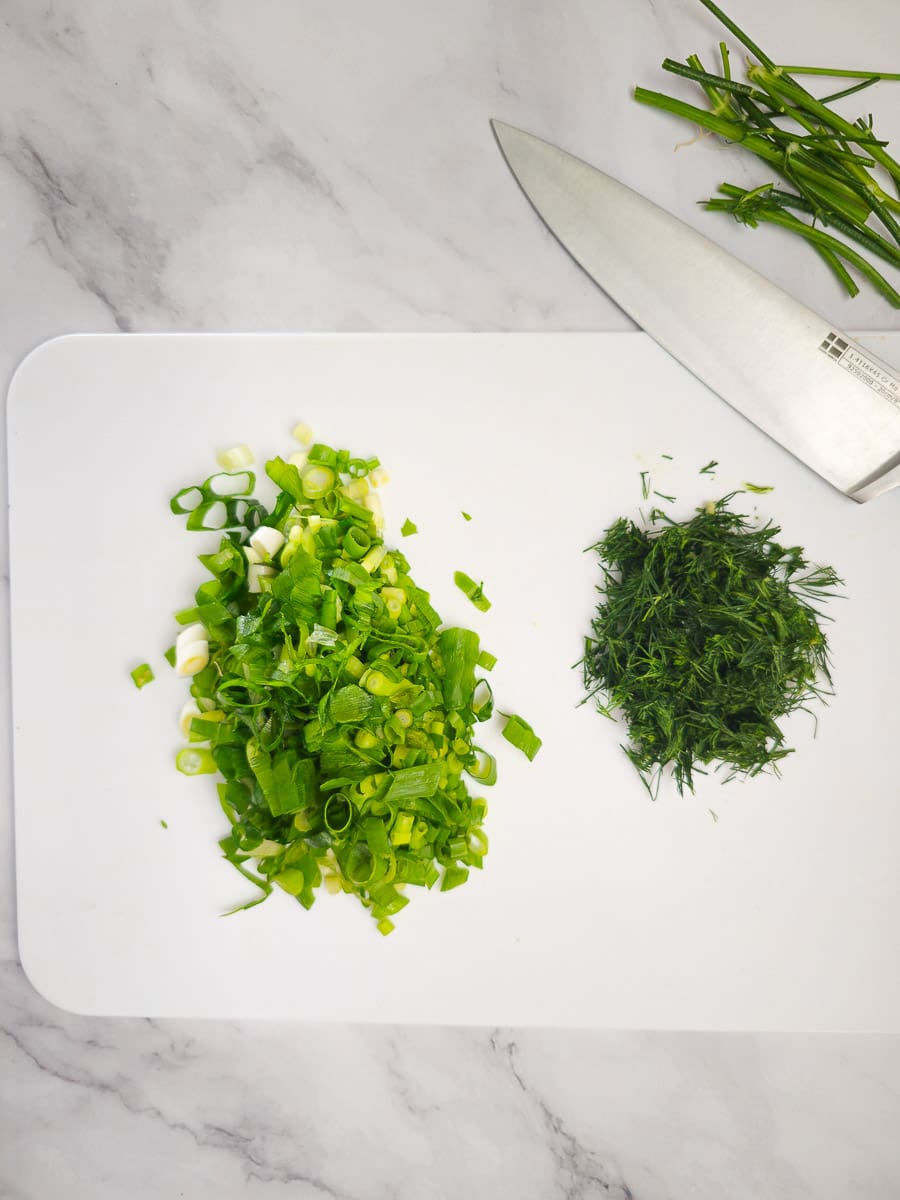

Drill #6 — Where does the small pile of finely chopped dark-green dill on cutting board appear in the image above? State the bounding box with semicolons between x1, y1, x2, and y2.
582;493;841;797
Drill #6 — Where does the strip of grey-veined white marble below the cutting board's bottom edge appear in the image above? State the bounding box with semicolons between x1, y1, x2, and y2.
0;964;900;1200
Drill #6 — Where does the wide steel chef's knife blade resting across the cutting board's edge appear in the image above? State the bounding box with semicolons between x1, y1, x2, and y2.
491;121;900;502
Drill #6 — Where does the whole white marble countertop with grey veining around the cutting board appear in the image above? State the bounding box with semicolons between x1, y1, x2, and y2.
0;0;900;1200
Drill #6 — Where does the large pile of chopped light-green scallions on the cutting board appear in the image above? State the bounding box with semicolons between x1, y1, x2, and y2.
170;434;540;934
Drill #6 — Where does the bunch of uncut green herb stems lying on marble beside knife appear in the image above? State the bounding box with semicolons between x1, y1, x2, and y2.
634;0;900;307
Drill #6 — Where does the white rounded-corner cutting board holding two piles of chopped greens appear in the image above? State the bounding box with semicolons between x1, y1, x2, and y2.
10;334;900;1031
